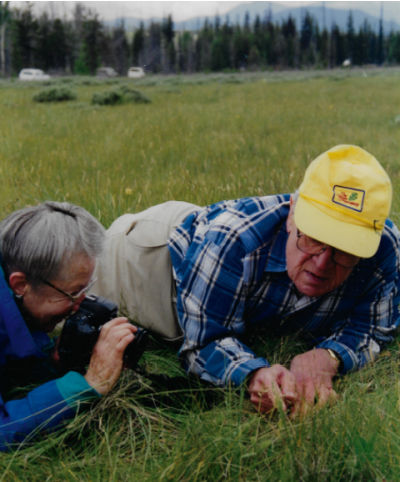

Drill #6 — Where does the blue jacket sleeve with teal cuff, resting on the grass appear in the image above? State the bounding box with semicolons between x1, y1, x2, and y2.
0;372;100;451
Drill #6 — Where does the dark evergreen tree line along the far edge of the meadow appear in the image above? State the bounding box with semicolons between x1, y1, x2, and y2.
0;1;400;76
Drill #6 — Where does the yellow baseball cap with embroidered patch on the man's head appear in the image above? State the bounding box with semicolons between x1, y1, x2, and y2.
294;145;392;258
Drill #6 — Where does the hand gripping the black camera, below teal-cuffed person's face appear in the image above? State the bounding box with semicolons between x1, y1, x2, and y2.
85;318;137;395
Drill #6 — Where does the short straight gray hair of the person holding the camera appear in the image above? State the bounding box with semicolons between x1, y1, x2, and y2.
0;201;105;284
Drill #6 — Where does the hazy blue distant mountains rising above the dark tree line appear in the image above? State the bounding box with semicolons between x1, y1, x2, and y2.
105;2;400;33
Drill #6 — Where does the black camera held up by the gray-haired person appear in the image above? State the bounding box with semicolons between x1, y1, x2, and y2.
58;295;148;373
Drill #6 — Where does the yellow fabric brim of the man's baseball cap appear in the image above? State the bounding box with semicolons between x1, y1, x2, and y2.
294;197;382;258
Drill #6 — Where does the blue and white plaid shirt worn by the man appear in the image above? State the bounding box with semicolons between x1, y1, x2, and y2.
169;194;400;386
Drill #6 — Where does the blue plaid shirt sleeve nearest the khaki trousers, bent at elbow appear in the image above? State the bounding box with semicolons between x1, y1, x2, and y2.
177;235;269;386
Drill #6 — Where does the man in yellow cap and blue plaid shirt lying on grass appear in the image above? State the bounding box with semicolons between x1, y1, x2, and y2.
95;145;400;413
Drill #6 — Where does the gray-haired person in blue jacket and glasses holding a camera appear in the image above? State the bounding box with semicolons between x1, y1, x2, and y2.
0;202;136;450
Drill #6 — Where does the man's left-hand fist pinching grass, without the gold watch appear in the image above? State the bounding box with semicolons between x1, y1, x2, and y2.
248;365;297;413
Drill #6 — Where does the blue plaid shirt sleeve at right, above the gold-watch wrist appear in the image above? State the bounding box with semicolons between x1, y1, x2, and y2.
317;227;400;373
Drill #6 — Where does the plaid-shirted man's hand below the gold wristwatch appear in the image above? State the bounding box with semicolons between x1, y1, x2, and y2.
290;348;339;415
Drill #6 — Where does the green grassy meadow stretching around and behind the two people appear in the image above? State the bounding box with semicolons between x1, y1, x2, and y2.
0;69;400;481
